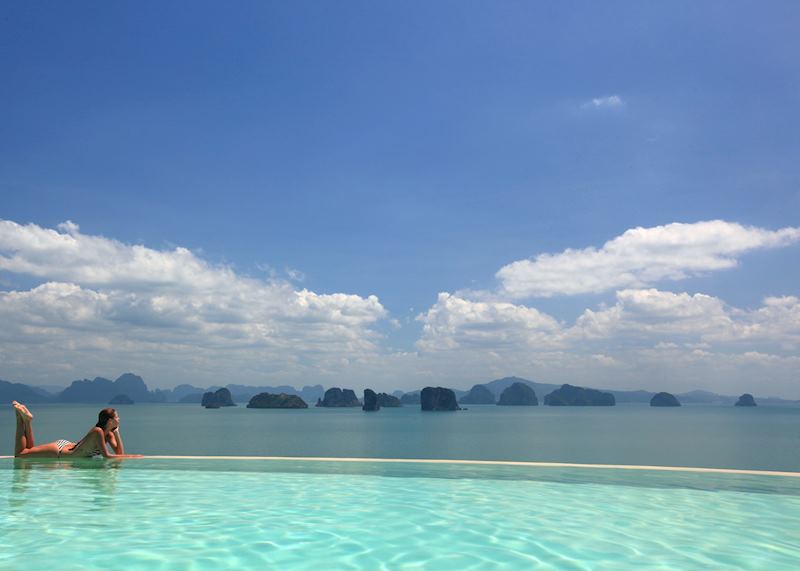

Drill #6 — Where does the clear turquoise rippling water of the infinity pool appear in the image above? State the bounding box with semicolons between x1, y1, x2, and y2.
0;459;800;571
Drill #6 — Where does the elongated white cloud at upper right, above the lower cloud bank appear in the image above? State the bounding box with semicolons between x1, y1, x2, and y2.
496;220;800;299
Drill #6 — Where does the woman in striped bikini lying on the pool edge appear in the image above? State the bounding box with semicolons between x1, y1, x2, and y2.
12;401;142;458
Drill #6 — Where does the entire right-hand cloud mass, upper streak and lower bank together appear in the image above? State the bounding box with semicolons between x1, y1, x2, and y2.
410;220;800;397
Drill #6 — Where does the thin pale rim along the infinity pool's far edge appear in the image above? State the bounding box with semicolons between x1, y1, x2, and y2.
0;455;800;478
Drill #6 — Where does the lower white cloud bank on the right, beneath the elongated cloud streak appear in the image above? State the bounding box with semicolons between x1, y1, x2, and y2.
418;289;800;398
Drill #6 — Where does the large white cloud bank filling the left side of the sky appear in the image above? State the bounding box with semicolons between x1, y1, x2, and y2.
0;221;387;386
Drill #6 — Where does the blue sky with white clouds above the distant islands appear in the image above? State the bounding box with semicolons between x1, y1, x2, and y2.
0;2;800;399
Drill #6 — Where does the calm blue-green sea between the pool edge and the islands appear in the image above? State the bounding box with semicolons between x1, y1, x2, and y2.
0;404;800;471
